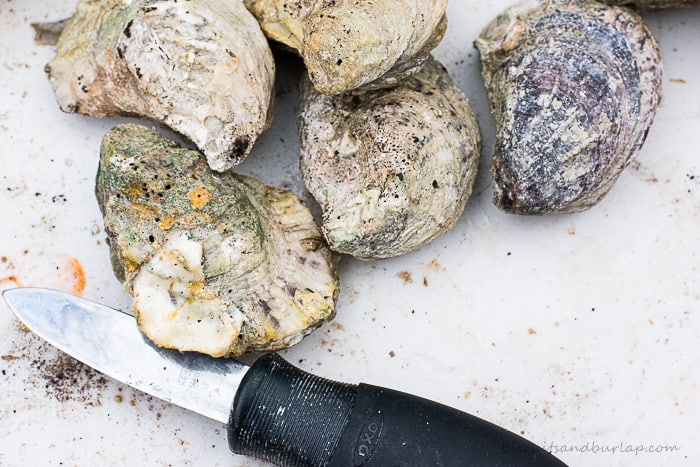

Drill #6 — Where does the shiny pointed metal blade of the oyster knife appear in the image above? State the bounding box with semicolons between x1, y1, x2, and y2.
2;288;248;423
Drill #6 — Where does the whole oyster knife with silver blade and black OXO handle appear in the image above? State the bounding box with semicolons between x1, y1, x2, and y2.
3;288;566;467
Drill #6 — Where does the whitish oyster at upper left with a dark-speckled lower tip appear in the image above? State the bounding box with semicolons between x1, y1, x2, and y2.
46;0;274;171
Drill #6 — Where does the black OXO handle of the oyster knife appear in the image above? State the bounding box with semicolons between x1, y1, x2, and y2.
228;354;566;467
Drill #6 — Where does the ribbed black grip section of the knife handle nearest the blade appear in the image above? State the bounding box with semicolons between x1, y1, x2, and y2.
228;354;357;467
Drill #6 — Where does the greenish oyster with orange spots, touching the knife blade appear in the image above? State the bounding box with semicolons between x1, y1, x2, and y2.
96;124;338;356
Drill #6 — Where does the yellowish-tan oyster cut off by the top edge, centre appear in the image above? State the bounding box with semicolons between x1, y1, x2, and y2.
245;0;447;95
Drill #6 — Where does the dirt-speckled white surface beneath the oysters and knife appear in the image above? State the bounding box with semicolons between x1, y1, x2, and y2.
0;0;700;466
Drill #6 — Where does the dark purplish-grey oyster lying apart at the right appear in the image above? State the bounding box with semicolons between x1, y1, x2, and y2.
475;0;662;214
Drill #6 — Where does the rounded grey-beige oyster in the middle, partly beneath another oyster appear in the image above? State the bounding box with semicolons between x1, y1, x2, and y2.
300;58;481;259
